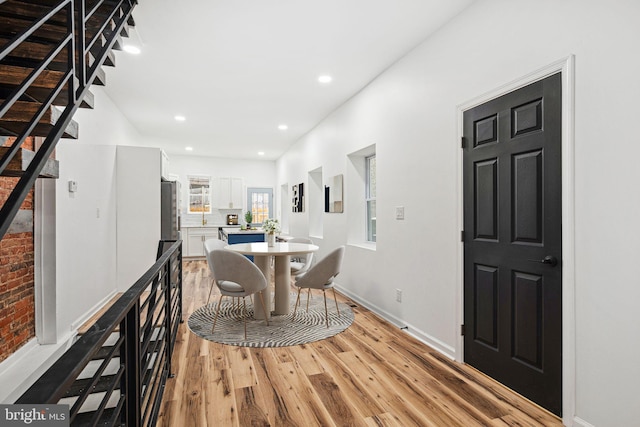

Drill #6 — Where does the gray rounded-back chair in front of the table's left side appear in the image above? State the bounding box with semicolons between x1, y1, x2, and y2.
211;249;269;339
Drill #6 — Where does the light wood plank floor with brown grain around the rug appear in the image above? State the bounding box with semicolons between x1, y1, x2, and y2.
158;261;562;427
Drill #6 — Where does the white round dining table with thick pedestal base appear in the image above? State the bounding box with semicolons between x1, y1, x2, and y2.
225;242;319;319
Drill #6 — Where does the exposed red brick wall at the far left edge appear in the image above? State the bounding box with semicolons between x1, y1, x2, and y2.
0;138;35;361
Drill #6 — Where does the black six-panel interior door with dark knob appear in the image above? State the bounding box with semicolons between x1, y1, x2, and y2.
463;74;562;415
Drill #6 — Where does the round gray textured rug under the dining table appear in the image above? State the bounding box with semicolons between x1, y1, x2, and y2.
188;291;354;347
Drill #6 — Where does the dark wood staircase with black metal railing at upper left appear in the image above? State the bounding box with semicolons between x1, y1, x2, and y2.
0;0;137;239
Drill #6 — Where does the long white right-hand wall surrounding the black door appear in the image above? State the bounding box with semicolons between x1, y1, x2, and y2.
277;0;640;426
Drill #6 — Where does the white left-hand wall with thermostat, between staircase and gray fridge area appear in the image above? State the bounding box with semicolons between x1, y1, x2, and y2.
56;86;140;336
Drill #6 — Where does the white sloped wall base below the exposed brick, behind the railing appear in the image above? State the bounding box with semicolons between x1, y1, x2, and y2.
0;332;75;403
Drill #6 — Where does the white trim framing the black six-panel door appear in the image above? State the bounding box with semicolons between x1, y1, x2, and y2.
454;55;576;425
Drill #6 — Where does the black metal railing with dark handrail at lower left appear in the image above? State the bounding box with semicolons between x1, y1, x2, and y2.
15;240;182;426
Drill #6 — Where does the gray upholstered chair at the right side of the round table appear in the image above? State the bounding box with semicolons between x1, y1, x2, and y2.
292;246;344;328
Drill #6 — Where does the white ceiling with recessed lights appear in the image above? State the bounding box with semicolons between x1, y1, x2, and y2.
105;0;473;159
